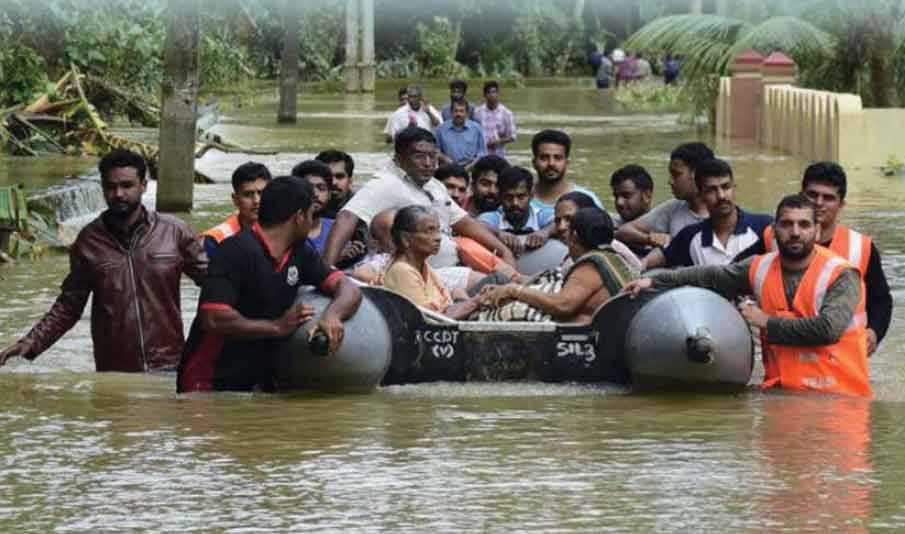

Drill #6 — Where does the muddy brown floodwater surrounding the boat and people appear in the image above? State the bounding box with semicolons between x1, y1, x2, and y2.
0;83;905;533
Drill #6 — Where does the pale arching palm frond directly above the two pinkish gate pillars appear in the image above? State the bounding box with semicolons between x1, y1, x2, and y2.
728;17;836;60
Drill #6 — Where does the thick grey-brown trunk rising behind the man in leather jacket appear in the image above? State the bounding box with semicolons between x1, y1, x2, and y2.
157;0;200;212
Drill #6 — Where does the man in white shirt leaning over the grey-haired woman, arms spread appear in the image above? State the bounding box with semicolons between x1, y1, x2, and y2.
323;127;515;268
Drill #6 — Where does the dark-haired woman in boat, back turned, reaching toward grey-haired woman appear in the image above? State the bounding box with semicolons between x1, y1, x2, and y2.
484;207;636;323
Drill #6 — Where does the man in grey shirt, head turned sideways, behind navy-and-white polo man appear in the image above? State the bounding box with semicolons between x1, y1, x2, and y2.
616;143;714;251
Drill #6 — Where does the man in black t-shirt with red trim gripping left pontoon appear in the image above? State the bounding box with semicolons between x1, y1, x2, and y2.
177;176;361;393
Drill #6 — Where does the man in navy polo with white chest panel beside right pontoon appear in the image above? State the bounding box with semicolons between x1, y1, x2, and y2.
643;159;773;269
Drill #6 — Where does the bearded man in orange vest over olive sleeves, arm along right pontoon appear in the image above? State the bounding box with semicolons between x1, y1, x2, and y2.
624;194;871;397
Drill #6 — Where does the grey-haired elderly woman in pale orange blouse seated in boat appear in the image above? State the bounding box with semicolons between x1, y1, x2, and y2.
383;206;483;319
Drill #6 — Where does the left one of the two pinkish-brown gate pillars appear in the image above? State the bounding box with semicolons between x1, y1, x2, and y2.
727;50;764;141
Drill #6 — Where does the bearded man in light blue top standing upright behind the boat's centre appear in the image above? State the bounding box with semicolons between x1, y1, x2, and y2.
531;130;603;221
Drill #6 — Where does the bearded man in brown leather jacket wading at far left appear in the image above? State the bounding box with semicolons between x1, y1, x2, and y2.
0;150;207;372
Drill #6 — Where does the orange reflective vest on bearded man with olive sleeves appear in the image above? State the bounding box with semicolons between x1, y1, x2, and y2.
748;245;871;396
